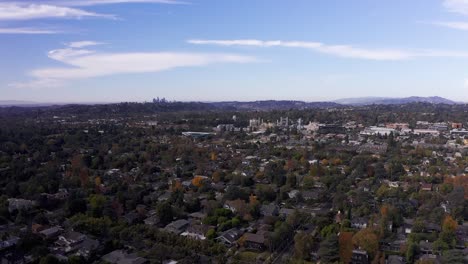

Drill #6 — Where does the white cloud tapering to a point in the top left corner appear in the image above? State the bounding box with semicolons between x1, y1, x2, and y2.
0;2;115;20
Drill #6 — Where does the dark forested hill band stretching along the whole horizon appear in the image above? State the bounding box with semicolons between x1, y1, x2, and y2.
0;101;467;118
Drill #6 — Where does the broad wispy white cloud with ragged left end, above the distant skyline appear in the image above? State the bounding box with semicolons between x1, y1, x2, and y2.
11;42;257;87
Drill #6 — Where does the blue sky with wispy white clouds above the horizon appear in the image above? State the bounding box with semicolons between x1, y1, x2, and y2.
0;0;468;102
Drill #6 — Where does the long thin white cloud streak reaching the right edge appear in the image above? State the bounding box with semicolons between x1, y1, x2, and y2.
187;39;468;61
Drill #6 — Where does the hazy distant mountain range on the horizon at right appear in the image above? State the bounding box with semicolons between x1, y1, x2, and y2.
334;96;458;105
